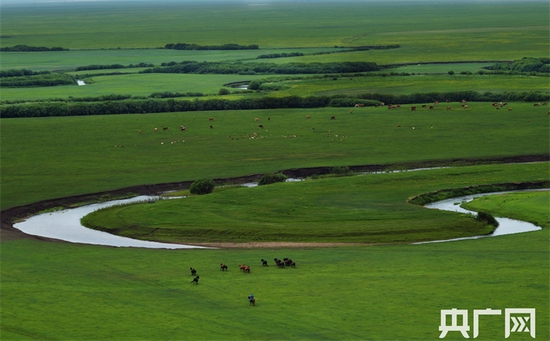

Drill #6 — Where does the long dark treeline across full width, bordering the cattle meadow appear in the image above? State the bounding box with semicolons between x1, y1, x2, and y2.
0;91;550;118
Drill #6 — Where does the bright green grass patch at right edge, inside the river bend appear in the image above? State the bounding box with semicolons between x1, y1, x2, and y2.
462;191;550;227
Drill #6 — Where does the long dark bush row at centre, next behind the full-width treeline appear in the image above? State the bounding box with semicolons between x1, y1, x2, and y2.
141;61;380;75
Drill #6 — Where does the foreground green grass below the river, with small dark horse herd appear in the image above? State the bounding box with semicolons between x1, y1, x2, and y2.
0;224;550;340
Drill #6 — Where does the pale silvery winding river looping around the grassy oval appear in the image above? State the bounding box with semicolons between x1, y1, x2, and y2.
14;190;541;249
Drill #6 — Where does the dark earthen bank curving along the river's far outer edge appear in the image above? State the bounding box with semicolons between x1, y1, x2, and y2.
0;155;550;247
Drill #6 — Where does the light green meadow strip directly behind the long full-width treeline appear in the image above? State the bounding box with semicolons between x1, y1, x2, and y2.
2;72;548;101
